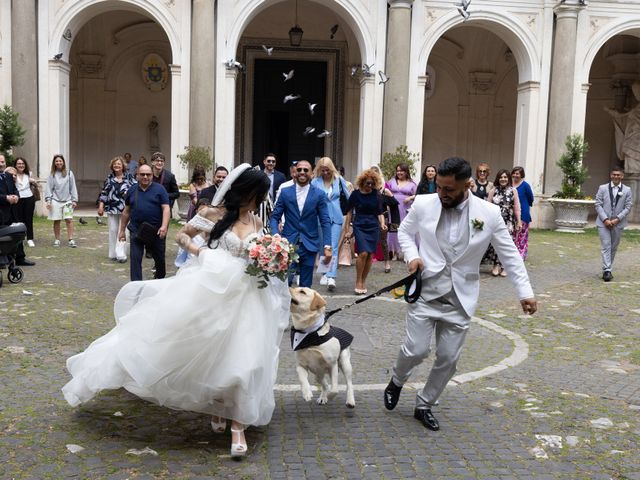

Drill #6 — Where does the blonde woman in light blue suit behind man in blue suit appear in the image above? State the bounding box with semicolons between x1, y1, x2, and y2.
311;157;349;292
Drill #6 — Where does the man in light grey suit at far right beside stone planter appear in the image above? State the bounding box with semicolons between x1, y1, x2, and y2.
596;167;631;282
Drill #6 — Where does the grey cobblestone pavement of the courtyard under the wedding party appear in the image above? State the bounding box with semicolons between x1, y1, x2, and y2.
0;220;640;479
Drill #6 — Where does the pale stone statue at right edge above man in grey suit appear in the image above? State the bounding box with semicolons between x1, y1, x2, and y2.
605;81;640;173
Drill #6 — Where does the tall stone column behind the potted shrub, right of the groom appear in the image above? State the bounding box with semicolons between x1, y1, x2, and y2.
544;0;583;195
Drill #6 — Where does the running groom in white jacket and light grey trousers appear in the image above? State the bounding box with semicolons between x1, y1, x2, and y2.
384;157;537;430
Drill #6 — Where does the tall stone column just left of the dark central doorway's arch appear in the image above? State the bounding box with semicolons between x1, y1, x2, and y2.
189;0;216;153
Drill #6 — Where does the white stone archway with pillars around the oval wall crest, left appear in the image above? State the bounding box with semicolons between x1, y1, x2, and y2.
38;0;190;188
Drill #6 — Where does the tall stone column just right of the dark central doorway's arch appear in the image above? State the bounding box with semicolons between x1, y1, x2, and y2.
376;0;413;155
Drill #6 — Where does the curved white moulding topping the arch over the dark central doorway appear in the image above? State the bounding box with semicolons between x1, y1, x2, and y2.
222;0;378;64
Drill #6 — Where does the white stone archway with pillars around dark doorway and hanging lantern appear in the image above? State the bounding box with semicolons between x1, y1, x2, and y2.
215;0;386;175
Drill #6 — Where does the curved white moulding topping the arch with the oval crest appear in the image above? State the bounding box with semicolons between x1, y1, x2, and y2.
48;0;180;64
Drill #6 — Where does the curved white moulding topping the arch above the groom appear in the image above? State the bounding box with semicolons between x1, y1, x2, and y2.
418;8;541;83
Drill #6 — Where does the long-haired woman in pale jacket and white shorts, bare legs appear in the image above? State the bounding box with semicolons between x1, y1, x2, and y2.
44;153;78;248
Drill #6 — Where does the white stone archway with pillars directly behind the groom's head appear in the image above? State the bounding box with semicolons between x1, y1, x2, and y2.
407;5;546;191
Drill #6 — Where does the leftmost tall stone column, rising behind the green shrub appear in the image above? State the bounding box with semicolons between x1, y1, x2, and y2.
11;0;38;172
